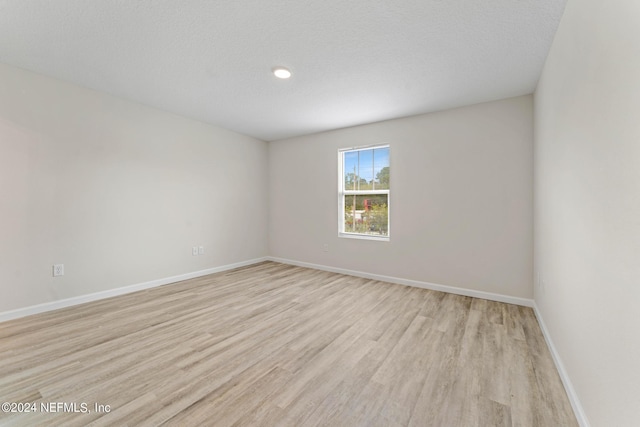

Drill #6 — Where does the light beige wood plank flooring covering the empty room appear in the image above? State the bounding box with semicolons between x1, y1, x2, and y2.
0;262;577;427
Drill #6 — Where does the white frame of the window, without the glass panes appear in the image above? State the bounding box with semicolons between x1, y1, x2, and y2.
338;144;391;242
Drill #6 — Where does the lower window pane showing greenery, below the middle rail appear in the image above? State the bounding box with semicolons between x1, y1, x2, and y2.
344;194;389;236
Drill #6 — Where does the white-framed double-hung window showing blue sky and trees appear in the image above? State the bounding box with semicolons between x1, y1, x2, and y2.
338;145;390;240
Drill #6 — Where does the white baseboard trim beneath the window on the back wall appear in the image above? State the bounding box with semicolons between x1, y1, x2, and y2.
267;256;533;307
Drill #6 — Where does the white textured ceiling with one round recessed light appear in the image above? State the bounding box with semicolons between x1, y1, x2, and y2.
0;0;566;141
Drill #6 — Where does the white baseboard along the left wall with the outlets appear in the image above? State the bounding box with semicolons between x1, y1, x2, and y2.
0;257;267;322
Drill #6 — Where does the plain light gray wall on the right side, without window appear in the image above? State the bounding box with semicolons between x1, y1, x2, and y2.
535;0;640;426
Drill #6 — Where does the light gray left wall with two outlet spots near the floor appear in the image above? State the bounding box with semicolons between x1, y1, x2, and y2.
0;61;268;312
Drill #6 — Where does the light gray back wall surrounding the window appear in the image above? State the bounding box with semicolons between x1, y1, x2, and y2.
269;96;533;298
